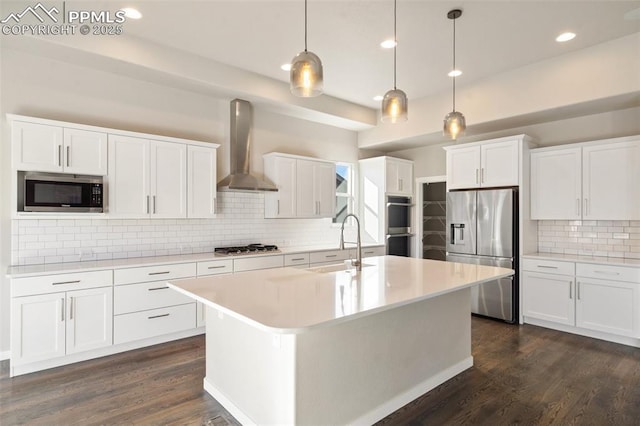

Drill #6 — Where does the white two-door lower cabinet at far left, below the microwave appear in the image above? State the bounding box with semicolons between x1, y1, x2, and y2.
11;273;113;366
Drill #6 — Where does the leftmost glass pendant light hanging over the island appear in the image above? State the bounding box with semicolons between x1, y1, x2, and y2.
289;0;322;98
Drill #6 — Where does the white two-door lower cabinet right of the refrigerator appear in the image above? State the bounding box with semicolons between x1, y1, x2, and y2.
522;259;640;345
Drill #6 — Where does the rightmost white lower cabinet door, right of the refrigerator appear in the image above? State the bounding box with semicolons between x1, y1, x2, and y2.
576;278;640;337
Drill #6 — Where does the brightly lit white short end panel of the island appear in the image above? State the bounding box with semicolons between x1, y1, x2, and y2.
204;307;296;425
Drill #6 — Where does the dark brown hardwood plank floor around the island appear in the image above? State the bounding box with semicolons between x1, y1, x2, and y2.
0;318;640;426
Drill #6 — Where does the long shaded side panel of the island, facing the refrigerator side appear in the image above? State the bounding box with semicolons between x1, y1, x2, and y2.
296;288;473;425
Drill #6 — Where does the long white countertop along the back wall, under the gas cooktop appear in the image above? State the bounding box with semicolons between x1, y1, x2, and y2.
7;244;381;278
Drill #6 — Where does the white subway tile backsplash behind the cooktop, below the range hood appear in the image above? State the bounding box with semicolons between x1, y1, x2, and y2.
11;192;350;265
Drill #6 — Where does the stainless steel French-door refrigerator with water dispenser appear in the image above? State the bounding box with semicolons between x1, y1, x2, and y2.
446;188;518;323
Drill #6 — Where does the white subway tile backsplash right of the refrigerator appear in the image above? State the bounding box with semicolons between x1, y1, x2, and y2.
538;220;640;259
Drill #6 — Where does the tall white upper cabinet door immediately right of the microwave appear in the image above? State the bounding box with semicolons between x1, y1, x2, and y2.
107;135;150;217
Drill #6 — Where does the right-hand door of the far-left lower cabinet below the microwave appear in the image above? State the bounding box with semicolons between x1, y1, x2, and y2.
66;287;113;354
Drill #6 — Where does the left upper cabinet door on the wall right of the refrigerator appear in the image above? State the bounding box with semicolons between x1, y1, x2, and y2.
531;148;582;220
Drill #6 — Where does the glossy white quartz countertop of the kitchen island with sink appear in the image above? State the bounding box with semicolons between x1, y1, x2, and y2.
169;256;514;333
